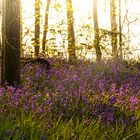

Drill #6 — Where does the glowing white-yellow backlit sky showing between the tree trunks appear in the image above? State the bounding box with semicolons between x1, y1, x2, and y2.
0;0;140;56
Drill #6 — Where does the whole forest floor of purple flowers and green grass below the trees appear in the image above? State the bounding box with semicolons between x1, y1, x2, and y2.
0;58;140;140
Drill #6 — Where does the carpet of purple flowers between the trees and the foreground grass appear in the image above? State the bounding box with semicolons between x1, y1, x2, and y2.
0;59;140;125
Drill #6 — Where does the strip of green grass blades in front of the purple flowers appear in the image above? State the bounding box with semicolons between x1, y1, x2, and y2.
0;112;140;140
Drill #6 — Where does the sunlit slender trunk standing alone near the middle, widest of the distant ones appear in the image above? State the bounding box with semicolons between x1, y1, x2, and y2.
66;0;76;61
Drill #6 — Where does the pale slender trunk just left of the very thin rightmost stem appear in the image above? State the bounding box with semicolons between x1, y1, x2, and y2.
110;0;118;58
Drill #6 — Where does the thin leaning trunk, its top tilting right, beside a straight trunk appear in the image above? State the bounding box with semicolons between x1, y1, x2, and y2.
42;0;51;53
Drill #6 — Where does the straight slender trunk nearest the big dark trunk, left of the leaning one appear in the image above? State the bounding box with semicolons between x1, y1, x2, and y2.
35;0;40;57
